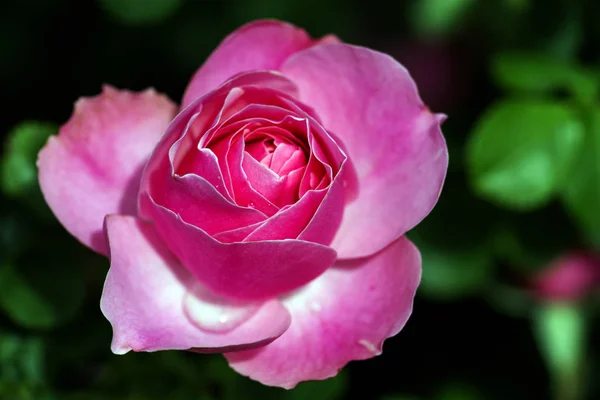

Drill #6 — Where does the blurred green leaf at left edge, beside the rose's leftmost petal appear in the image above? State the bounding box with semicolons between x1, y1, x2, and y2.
0;121;58;197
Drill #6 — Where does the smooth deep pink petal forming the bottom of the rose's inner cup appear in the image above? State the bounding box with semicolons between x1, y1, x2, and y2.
148;199;336;300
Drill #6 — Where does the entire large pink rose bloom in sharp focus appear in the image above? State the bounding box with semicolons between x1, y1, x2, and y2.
38;21;448;388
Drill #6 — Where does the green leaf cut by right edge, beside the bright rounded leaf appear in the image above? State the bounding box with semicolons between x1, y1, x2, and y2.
562;109;600;246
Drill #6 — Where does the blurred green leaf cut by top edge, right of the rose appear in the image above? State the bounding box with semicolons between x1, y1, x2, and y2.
410;0;476;37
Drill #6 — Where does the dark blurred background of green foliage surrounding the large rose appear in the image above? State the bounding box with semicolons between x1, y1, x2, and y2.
0;0;600;400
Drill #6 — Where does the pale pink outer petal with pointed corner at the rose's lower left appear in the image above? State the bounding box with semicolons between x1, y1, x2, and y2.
100;215;290;354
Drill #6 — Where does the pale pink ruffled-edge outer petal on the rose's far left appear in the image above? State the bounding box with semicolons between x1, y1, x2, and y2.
38;86;176;254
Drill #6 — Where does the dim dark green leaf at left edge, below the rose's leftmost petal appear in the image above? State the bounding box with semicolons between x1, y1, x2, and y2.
0;255;85;329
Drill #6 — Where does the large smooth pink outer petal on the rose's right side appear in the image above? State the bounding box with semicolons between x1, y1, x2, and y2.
281;43;448;258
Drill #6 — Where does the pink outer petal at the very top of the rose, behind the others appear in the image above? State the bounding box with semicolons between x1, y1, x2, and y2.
183;20;312;107
